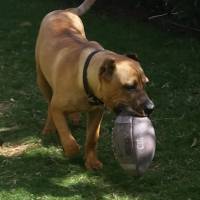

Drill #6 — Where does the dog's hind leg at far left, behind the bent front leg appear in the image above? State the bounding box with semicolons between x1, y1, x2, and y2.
37;66;56;134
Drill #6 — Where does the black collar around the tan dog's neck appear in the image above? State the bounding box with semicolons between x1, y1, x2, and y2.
83;50;104;105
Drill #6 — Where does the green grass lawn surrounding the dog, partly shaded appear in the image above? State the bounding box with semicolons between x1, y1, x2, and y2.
0;0;200;200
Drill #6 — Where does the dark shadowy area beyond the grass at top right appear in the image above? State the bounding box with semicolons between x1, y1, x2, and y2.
67;0;200;34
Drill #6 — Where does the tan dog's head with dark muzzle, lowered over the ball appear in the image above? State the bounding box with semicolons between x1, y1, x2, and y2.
99;54;154;116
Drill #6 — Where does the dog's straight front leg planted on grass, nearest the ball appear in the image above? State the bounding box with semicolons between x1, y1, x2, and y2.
85;108;103;170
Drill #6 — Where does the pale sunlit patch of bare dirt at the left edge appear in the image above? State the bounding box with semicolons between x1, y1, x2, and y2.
0;144;38;157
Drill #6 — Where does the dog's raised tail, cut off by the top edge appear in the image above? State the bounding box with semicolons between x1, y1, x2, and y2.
68;0;96;16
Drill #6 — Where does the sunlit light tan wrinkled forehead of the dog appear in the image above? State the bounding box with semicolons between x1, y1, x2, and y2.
116;60;147;86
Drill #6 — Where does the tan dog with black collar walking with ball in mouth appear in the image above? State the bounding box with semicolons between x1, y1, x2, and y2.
36;0;153;169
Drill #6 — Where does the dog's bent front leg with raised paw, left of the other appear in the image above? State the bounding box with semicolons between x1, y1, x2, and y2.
51;101;80;157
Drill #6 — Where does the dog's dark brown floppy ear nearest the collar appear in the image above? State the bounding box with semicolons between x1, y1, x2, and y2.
99;59;116;81
